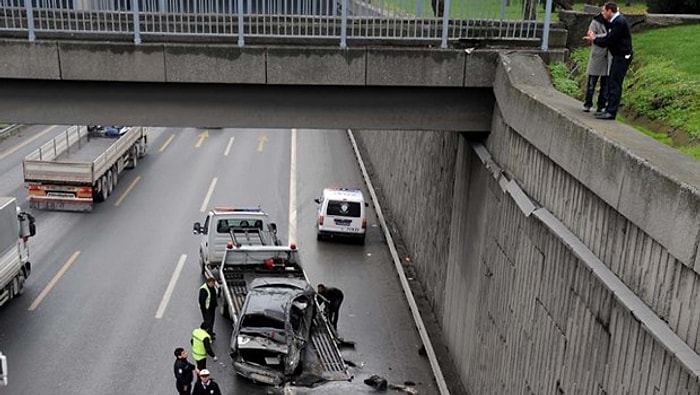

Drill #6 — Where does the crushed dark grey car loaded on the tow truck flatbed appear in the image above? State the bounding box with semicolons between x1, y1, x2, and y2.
231;277;316;385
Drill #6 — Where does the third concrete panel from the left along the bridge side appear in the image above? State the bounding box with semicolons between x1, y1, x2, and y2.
165;44;267;84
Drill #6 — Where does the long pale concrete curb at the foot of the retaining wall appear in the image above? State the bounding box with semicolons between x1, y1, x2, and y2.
347;129;450;395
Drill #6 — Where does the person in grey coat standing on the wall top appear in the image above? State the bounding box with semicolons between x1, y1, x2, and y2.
583;13;610;113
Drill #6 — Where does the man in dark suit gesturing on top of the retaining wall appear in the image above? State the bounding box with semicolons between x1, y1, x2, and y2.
585;3;632;120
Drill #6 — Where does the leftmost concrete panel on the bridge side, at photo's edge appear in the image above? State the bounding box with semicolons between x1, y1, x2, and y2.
0;40;61;80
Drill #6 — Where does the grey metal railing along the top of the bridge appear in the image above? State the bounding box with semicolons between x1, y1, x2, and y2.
0;0;552;50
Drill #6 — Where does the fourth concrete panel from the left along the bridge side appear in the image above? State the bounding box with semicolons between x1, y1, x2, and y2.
267;46;366;85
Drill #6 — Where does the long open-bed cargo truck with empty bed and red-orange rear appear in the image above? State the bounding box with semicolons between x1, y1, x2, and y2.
22;125;148;211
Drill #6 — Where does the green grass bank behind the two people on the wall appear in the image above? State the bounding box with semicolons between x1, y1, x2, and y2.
550;25;700;159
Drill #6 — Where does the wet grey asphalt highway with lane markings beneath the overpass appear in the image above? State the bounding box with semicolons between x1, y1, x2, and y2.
0;126;437;395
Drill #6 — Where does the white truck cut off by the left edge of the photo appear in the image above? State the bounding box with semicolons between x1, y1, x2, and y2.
0;197;36;306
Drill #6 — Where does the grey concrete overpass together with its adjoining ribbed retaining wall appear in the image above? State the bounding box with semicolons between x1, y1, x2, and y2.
0;2;700;394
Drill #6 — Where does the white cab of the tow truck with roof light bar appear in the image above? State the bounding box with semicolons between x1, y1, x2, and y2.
192;206;280;274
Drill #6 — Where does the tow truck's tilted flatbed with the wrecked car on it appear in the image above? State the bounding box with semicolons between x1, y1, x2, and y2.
206;240;351;385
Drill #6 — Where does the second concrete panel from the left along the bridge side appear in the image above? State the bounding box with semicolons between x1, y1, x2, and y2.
58;42;166;82
